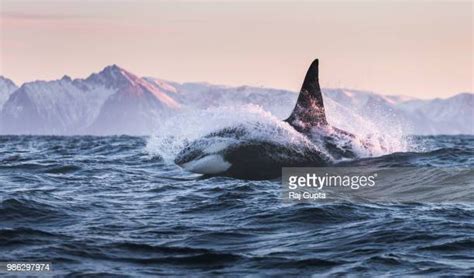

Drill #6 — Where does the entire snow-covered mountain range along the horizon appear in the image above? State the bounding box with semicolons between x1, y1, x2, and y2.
0;65;474;135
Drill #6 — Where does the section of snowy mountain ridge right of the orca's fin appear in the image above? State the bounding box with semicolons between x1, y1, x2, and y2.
323;89;474;135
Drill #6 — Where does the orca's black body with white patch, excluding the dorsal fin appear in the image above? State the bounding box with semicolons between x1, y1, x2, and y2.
175;125;329;179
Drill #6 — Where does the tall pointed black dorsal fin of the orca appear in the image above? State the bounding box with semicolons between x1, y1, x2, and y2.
285;59;328;132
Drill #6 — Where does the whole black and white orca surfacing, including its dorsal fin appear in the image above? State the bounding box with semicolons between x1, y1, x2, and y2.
175;59;370;179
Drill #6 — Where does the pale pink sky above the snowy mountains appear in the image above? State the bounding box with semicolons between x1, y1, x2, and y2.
0;0;474;98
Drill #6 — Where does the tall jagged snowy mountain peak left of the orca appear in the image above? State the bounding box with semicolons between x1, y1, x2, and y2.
0;65;179;134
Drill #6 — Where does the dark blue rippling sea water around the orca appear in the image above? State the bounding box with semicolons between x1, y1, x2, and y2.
0;136;474;277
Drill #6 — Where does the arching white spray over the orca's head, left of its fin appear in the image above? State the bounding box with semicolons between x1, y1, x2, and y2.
147;104;312;161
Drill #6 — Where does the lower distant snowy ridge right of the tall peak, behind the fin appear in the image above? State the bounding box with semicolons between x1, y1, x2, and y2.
140;80;474;135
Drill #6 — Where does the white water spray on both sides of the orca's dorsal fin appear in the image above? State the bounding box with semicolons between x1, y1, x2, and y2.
147;100;410;162
